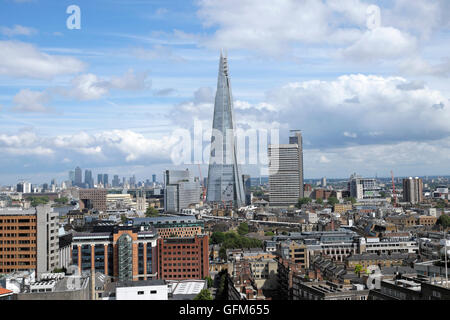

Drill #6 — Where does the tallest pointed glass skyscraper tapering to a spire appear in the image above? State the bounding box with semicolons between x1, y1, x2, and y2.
206;53;245;208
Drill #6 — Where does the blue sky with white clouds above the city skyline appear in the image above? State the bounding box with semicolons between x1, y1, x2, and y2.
0;0;450;185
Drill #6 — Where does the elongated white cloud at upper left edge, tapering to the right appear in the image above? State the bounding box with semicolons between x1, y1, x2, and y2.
0;41;85;79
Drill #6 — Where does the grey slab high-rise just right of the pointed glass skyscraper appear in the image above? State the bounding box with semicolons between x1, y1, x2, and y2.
268;130;304;207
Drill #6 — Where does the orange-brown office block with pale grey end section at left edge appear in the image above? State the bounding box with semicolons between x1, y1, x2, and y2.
0;205;59;276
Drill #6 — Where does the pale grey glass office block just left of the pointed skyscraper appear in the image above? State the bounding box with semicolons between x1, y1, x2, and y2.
164;169;201;212
